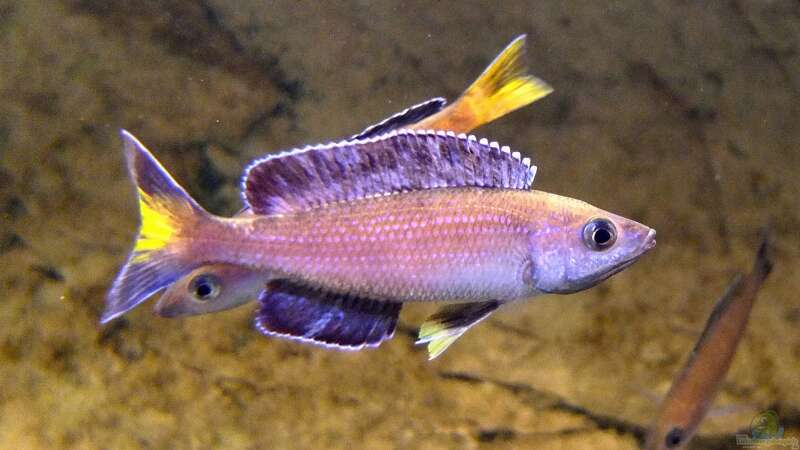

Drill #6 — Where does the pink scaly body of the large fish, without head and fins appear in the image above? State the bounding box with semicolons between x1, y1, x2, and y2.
206;189;535;301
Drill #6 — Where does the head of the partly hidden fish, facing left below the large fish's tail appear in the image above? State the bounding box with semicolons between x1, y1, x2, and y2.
153;264;271;317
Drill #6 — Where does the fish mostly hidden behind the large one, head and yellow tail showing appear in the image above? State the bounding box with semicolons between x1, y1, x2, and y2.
153;34;553;317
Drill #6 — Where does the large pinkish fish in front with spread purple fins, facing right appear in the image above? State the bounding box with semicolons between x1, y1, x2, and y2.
101;129;656;359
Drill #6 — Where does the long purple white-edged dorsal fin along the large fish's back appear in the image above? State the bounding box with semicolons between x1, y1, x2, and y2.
242;130;536;215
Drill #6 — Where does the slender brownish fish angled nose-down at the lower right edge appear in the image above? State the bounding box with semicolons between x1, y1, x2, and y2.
645;232;773;450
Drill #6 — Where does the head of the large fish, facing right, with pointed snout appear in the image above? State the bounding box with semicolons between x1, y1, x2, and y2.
527;194;656;294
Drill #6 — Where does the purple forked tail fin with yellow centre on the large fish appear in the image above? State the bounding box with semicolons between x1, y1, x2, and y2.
100;130;208;323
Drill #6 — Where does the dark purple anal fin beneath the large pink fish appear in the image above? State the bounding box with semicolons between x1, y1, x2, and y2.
255;280;402;350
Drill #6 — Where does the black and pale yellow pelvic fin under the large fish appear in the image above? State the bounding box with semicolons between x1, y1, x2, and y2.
416;300;500;359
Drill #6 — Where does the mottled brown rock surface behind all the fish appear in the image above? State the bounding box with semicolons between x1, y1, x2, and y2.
0;0;800;449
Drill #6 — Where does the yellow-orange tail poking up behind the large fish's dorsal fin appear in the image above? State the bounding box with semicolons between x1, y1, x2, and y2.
412;35;553;133
